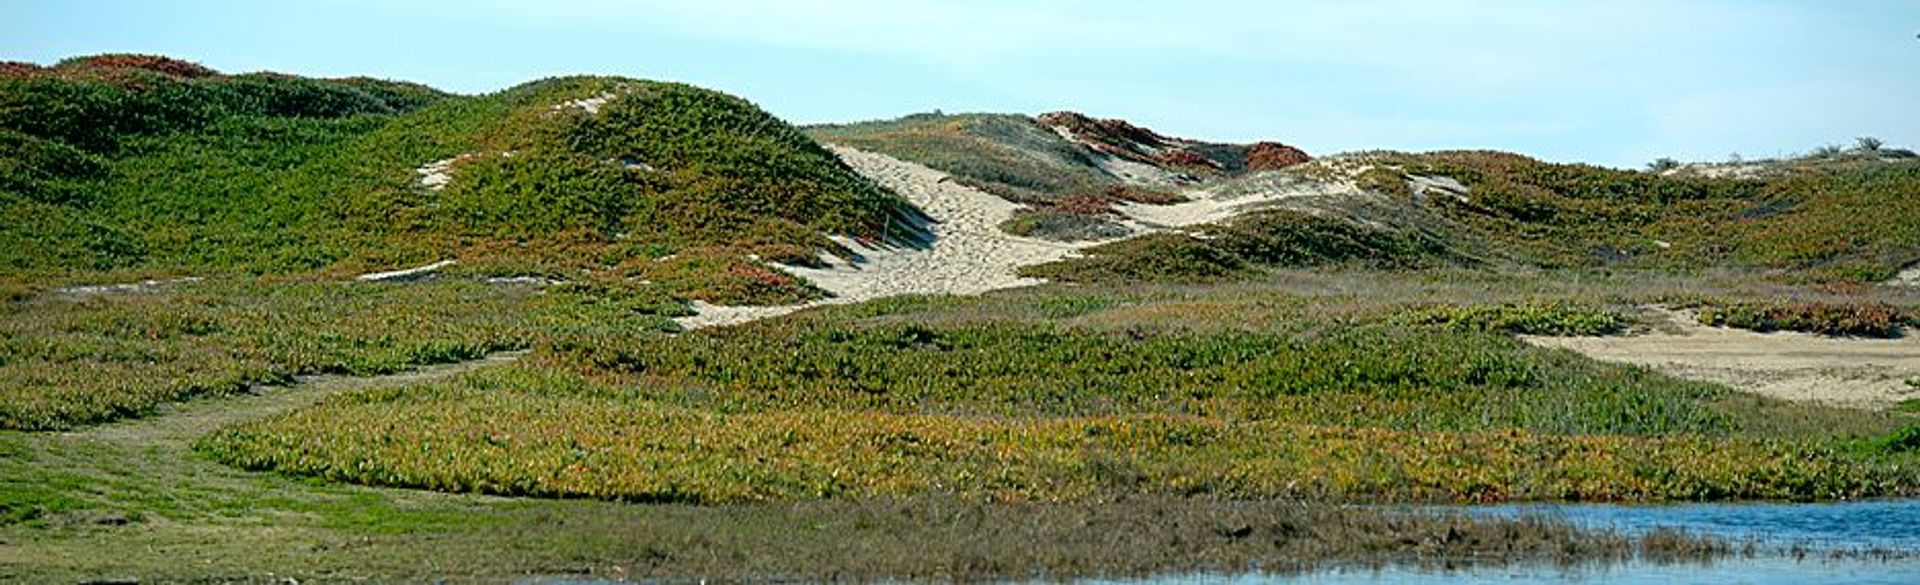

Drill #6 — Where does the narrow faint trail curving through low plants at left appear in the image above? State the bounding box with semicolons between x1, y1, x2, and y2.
67;351;526;449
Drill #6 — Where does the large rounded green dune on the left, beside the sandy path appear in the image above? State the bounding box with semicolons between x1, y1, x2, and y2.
0;56;916;301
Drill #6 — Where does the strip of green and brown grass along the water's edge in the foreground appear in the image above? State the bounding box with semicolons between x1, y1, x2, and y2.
0;421;1728;583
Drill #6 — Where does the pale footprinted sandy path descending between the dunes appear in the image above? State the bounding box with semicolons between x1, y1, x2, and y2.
678;146;1096;330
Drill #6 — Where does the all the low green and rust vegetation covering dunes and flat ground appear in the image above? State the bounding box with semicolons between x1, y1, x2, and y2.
0;56;1920;581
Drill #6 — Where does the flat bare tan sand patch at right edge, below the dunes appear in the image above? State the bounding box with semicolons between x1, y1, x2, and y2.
1524;311;1920;409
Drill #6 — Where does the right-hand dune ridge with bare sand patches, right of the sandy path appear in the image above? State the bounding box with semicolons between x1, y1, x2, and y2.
808;113;1920;282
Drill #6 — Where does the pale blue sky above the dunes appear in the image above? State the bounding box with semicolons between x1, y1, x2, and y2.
0;0;1920;167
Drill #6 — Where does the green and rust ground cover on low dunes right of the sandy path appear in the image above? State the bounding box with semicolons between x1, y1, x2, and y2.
1029;152;1920;286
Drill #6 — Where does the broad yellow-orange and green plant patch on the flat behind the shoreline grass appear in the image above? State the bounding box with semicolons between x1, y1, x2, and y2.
202;283;1920;504
